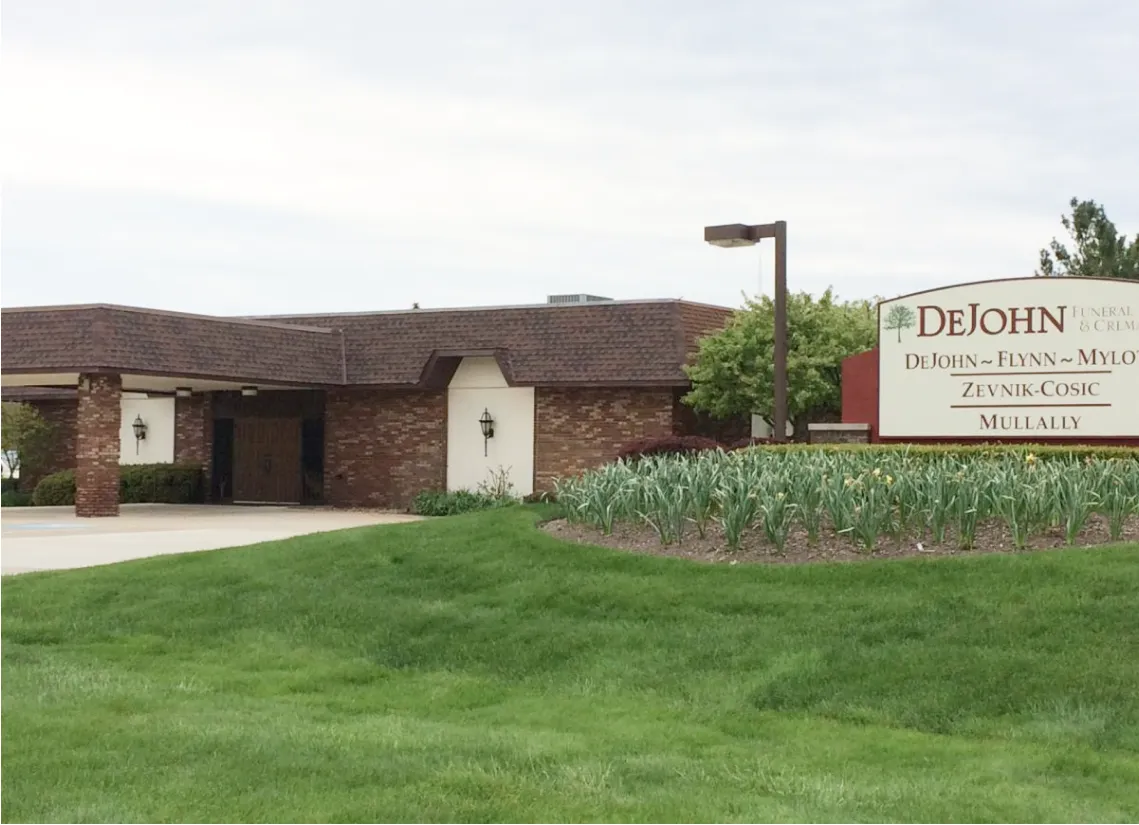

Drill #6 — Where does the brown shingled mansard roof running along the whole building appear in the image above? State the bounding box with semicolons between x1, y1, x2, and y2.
2;301;730;386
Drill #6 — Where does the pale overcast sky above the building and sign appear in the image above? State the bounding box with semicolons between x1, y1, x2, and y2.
0;0;1139;313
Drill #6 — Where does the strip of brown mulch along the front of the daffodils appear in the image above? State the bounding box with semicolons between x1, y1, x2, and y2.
542;515;1139;564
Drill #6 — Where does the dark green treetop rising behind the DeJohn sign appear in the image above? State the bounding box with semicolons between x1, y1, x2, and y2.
1036;198;1139;280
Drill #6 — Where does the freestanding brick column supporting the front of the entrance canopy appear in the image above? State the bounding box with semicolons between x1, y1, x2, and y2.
75;374;123;516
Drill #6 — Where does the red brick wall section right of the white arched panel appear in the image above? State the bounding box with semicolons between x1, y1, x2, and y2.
534;387;674;490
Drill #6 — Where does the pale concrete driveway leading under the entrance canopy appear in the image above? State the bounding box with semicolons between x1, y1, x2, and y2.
0;504;417;575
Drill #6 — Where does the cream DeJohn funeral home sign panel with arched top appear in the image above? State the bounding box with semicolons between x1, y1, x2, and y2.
878;278;1139;439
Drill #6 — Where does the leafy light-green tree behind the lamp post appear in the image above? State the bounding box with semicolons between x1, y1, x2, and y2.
685;289;878;440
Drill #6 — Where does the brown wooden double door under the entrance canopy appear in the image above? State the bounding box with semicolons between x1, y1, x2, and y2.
233;418;302;504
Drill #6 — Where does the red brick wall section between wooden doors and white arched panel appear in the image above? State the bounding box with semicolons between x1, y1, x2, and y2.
325;389;446;508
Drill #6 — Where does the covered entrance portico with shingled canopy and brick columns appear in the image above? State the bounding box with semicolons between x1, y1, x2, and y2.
0;307;342;516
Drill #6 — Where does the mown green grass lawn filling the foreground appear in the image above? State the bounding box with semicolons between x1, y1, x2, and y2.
2;508;1139;823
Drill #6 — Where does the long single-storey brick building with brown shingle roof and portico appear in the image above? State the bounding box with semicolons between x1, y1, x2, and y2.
0;300;751;515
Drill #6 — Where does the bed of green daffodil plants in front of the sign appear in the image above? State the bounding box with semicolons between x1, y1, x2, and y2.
557;448;1139;557
